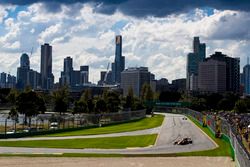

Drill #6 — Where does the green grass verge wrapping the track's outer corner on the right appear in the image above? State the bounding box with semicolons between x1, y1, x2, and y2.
176;116;231;156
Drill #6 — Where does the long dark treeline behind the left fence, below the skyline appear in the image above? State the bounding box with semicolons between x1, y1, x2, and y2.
0;84;154;126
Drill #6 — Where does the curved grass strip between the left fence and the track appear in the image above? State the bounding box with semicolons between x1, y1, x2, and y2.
39;115;164;137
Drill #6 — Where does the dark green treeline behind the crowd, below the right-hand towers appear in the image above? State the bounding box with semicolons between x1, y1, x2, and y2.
158;91;250;113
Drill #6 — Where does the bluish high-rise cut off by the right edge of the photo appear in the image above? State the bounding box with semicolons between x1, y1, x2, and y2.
242;60;250;95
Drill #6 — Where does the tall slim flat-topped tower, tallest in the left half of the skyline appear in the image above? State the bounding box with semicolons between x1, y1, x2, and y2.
41;43;54;90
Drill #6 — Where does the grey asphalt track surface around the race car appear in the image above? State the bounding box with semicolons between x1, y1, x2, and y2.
0;114;217;154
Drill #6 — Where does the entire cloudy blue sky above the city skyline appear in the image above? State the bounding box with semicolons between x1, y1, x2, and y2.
0;0;250;83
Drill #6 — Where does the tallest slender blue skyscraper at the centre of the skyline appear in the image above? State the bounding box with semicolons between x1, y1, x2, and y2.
112;35;125;84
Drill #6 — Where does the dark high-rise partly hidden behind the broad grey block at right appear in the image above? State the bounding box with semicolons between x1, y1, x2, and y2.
208;52;240;93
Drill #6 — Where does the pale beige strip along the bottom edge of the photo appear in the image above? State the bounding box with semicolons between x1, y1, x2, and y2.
0;157;235;167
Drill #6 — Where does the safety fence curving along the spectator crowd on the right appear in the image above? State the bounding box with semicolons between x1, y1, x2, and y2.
155;106;250;167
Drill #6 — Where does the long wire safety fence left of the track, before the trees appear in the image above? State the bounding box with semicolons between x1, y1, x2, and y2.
0;110;146;138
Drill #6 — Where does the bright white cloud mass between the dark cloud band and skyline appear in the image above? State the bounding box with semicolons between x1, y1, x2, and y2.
0;3;250;82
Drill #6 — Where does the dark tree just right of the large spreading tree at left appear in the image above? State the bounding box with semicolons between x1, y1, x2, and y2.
52;86;69;114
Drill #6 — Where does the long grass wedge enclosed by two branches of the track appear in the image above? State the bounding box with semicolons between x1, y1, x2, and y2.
0;134;157;149
